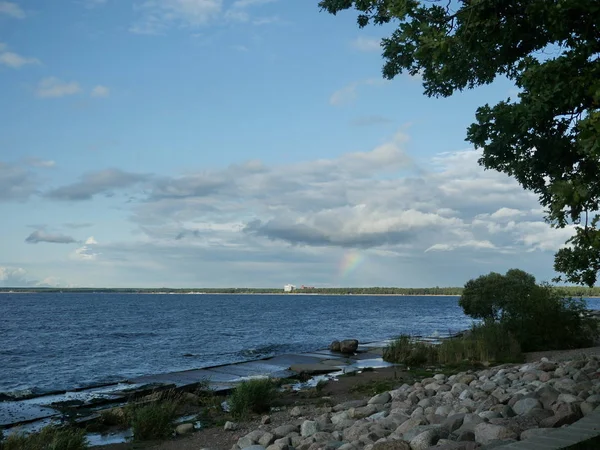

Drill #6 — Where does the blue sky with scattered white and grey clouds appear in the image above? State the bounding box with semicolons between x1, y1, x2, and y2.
0;0;572;287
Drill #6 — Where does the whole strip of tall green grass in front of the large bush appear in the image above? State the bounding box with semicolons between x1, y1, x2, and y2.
383;323;523;368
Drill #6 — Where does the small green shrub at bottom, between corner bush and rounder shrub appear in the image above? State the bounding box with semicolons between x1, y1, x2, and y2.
131;400;178;441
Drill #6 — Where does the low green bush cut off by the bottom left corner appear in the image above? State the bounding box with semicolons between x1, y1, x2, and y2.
2;426;88;450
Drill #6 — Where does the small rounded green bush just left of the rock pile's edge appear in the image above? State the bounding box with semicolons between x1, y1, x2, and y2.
229;378;277;418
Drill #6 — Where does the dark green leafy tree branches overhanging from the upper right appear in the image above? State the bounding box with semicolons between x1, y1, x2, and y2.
319;0;600;286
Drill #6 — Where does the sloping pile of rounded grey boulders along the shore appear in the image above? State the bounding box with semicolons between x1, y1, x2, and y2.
232;357;600;450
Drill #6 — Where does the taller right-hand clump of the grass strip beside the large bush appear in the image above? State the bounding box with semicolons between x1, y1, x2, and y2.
437;322;523;366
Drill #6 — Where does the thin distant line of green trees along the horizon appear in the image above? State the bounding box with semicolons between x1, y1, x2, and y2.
0;286;600;297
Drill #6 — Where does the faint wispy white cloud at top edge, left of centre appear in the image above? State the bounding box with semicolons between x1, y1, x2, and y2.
130;0;223;34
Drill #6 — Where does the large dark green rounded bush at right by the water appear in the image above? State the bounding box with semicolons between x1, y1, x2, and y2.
459;269;598;352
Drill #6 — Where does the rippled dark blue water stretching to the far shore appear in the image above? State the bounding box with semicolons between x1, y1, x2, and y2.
0;293;600;392
